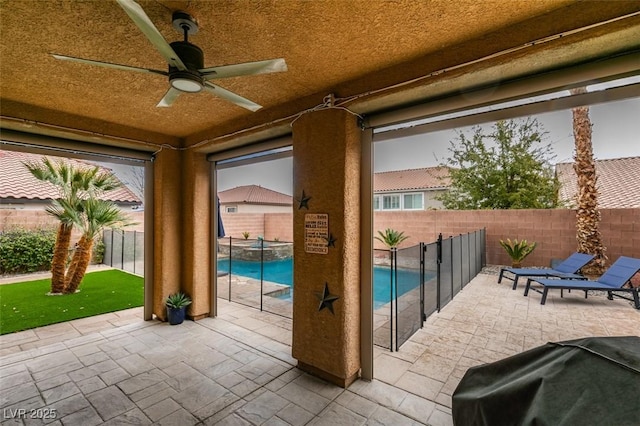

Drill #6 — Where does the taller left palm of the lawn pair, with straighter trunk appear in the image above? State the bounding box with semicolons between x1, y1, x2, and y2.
23;157;120;293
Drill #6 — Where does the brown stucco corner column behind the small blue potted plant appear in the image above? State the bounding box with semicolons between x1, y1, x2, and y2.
147;149;211;320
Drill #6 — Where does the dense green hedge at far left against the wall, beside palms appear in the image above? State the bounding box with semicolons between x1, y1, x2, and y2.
0;228;56;274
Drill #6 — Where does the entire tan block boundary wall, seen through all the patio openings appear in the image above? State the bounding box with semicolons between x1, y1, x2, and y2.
7;209;640;266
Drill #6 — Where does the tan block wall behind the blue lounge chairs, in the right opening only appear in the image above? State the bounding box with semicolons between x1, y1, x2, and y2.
374;209;640;266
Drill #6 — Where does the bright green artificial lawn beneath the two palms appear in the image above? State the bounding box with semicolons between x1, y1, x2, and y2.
0;269;144;334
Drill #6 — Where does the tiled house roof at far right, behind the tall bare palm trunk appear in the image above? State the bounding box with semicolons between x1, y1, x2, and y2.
556;157;640;209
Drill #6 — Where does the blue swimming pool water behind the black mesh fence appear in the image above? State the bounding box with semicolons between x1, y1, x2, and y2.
218;258;428;309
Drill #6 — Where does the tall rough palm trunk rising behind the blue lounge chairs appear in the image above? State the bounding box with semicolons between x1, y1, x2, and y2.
571;87;607;275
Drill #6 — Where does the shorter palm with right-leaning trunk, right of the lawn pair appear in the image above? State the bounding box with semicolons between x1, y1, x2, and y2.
64;197;130;294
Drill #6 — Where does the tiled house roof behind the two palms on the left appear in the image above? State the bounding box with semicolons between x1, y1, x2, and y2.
0;150;142;204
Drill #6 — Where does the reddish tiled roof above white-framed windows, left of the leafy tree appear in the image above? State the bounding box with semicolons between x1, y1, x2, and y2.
373;166;451;192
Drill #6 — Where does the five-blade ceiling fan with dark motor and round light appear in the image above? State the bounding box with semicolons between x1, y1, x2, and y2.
52;0;287;111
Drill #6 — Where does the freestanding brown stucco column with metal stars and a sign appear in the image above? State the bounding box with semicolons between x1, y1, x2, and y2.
292;109;361;387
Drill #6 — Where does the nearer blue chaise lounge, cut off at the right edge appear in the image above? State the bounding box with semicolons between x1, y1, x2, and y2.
524;256;640;309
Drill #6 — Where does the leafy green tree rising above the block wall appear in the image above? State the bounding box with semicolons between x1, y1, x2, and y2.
438;118;559;210
